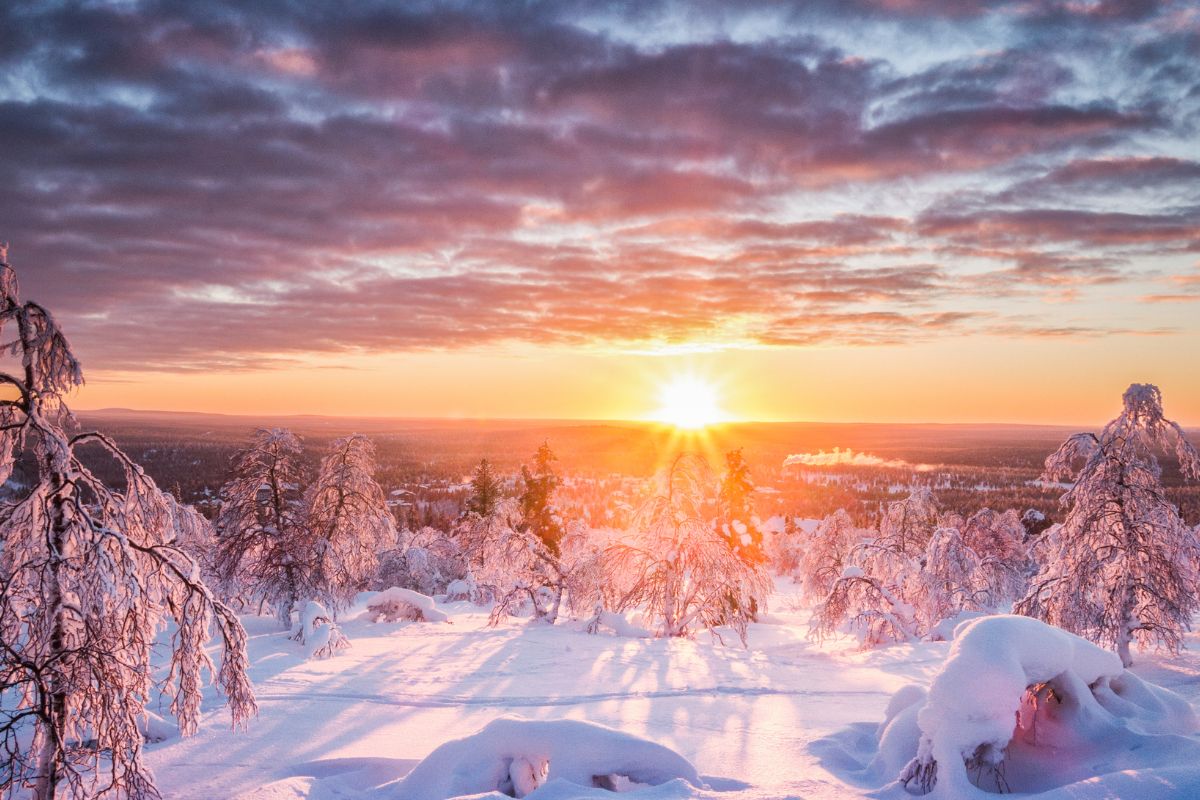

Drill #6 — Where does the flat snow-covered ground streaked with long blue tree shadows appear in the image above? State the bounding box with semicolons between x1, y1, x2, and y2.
148;582;1200;800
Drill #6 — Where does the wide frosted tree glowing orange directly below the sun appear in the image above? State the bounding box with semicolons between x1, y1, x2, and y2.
606;452;770;642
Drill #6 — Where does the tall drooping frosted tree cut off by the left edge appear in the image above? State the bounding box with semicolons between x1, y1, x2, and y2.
0;247;256;800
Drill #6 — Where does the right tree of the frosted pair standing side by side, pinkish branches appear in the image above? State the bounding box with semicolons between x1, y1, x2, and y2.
305;433;396;612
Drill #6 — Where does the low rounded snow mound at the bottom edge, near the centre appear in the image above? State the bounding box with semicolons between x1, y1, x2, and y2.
389;717;703;800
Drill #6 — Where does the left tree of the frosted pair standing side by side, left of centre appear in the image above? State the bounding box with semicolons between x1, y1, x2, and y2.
215;428;312;630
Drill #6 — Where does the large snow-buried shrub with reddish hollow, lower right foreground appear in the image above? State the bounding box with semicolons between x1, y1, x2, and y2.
897;615;1200;799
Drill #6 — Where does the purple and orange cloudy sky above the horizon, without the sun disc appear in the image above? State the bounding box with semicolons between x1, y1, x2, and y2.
0;0;1200;425
